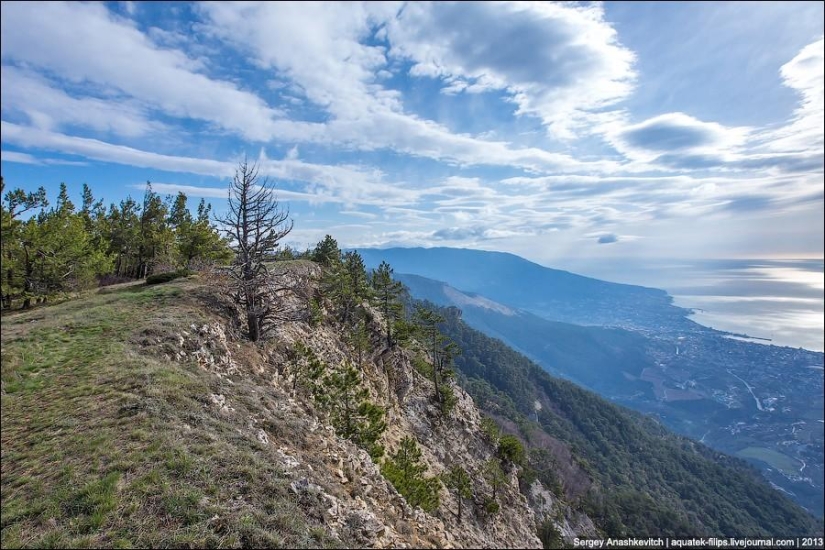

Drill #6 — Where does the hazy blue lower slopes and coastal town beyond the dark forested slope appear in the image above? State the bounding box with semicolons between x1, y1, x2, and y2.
398;275;823;517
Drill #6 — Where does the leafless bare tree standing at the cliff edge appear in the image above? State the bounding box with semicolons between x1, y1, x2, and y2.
216;159;293;342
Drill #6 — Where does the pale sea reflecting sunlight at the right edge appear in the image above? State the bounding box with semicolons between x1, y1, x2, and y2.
552;259;825;351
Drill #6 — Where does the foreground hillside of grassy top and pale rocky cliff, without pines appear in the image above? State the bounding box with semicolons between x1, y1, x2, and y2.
2;262;552;548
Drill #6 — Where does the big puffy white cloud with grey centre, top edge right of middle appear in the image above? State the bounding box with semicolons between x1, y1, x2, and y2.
387;2;635;138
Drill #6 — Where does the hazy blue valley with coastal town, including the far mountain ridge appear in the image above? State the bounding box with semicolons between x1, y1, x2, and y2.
365;249;825;517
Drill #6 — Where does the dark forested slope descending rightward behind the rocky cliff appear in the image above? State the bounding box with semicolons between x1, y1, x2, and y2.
432;310;822;537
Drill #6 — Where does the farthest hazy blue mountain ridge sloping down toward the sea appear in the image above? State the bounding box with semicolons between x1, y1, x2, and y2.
358;248;700;330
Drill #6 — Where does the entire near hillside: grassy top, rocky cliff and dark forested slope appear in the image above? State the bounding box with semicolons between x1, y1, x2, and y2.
1;261;821;548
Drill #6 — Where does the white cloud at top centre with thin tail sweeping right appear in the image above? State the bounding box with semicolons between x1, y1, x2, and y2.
196;2;615;172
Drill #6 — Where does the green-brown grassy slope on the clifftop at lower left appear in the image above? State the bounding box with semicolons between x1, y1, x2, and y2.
0;280;335;548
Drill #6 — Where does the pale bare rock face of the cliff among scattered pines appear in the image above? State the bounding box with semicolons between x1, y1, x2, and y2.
139;266;592;548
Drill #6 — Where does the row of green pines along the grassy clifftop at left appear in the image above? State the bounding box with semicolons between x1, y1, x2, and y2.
0;177;232;309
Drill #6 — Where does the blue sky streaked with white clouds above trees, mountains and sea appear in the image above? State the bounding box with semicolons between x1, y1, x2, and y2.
0;2;825;264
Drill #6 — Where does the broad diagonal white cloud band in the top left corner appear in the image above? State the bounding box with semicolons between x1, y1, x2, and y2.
0;2;279;140
